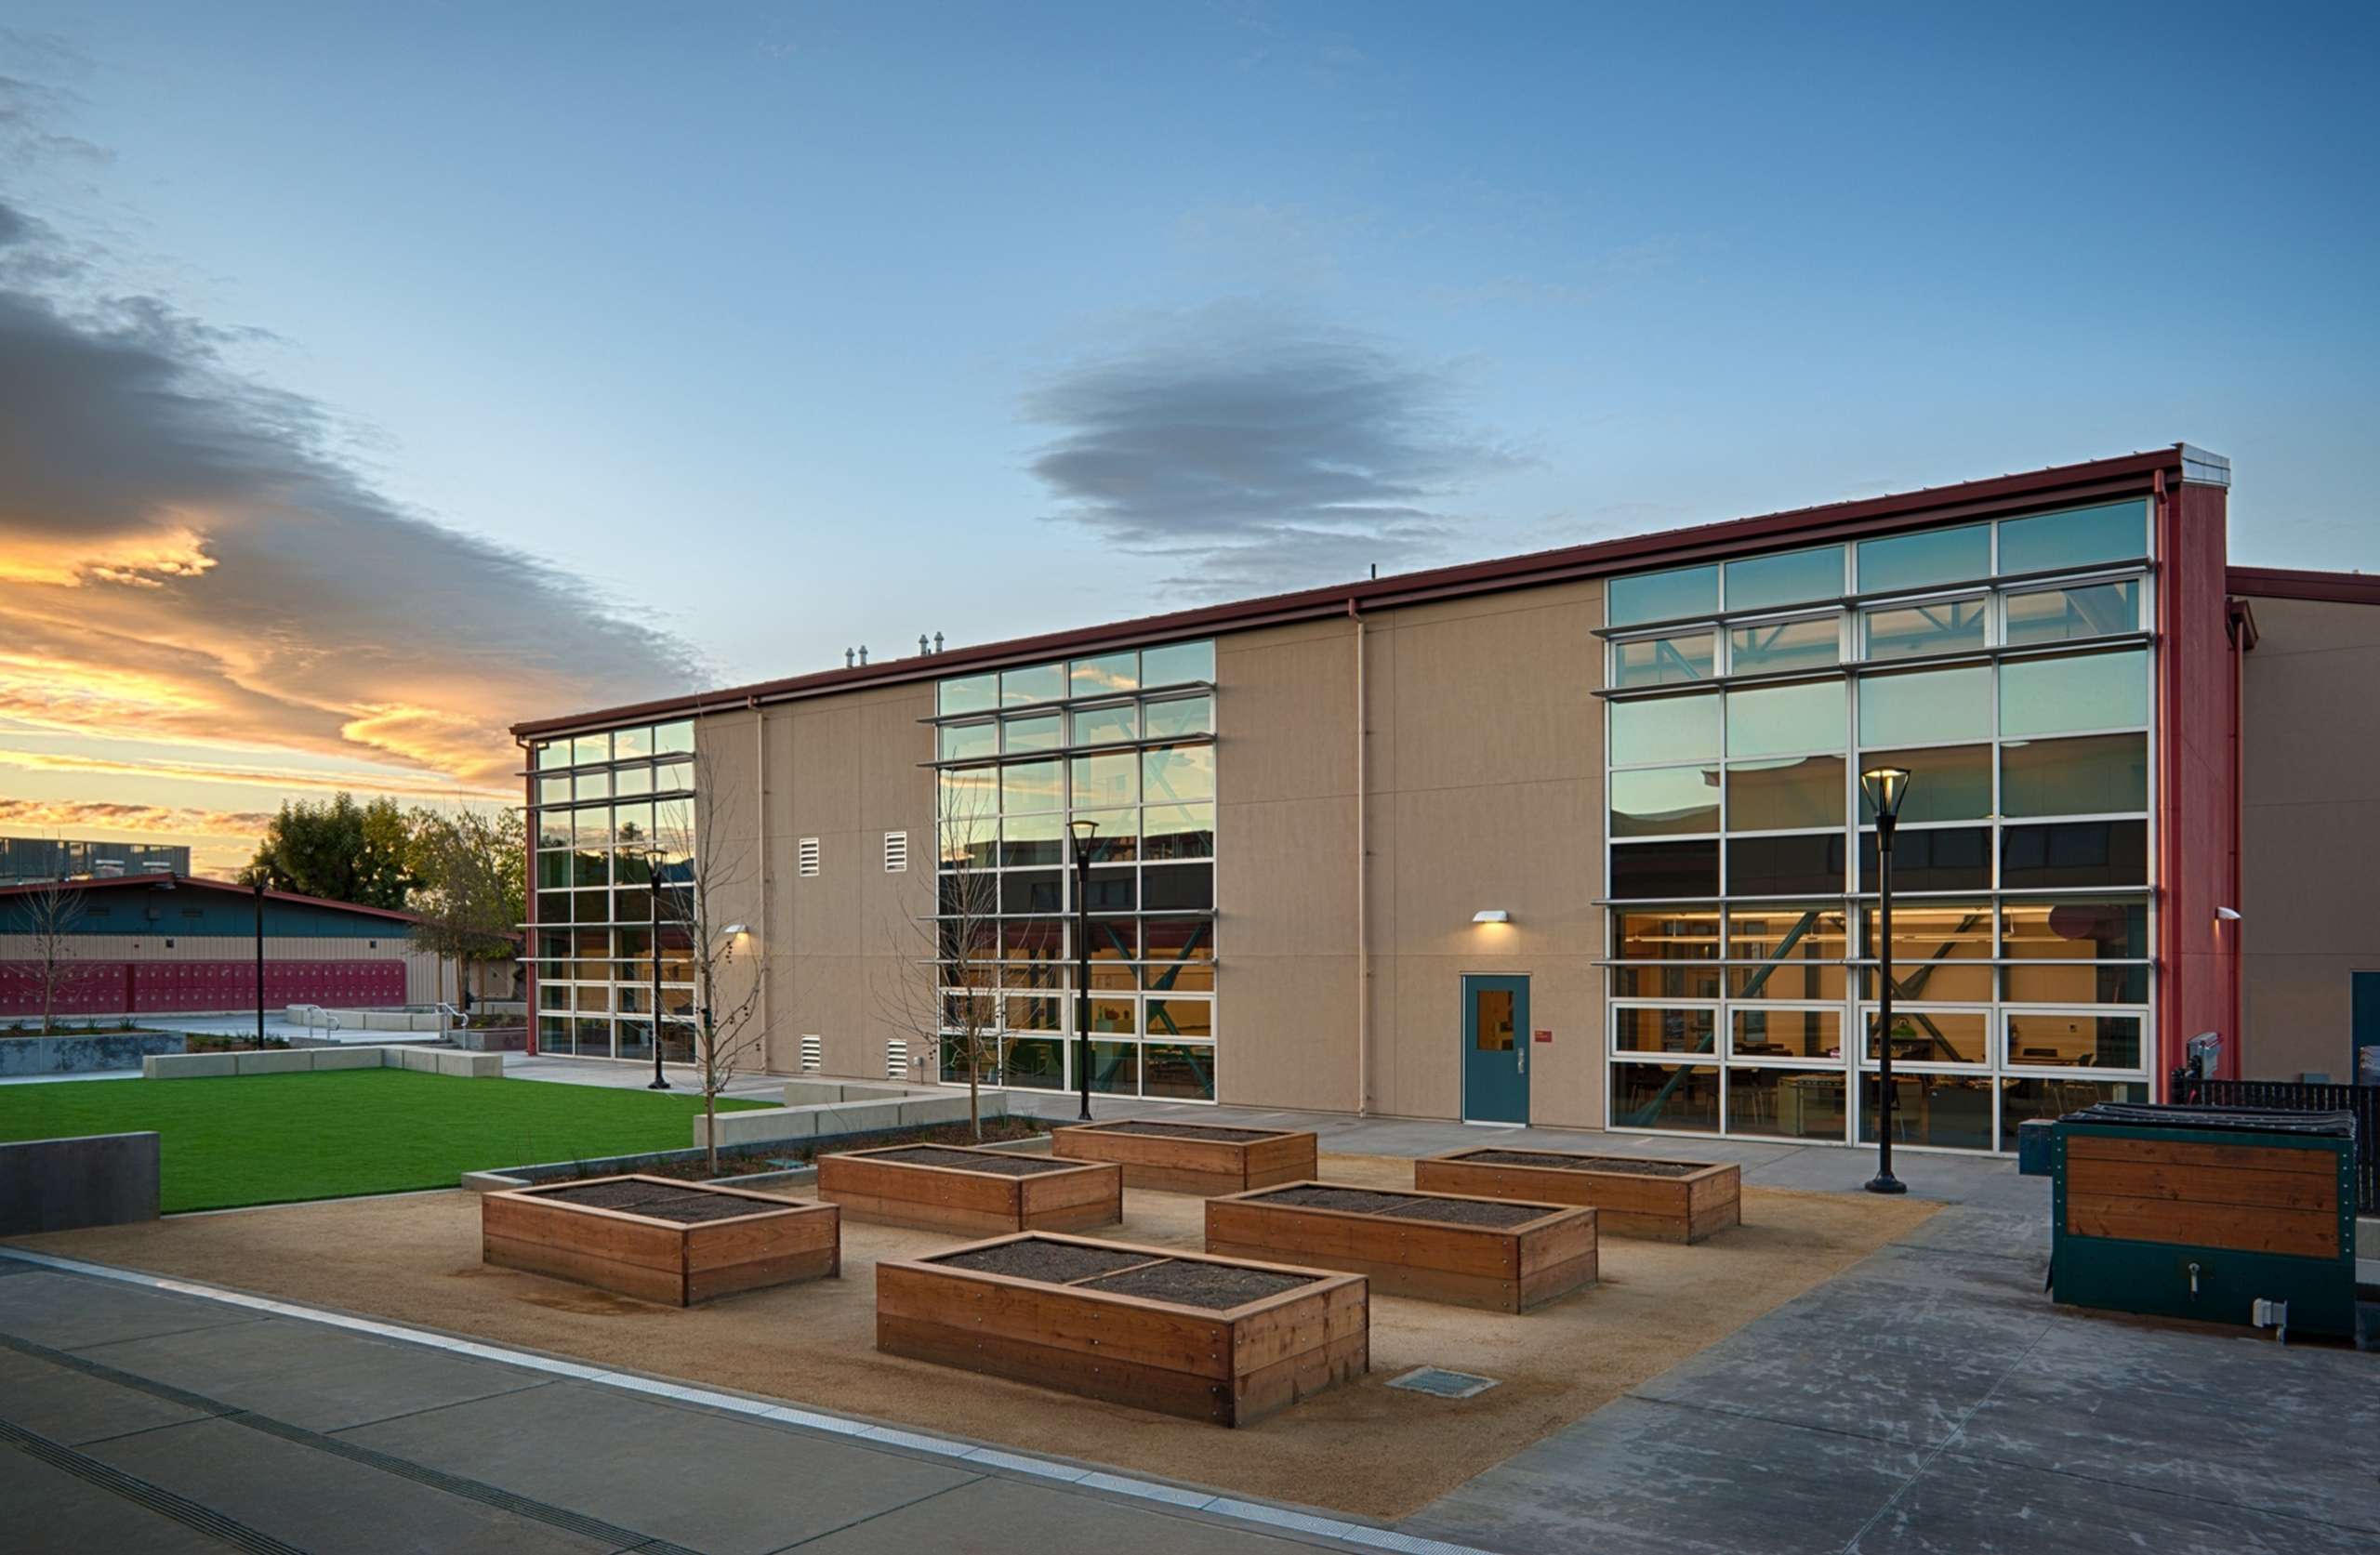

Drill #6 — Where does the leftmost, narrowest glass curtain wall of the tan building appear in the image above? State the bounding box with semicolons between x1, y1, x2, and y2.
528;720;695;1062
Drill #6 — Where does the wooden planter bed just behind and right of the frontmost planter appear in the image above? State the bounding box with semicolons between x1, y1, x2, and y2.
1207;1181;1594;1312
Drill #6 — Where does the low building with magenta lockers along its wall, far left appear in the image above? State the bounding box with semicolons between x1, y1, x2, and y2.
0;875;469;1020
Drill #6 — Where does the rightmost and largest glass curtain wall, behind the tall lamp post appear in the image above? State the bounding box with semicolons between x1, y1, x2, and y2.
1604;502;2154;1151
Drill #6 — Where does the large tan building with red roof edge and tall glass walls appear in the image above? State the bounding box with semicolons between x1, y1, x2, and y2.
517;444;2373;1151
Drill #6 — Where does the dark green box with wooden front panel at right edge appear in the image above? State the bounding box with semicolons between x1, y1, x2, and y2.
2049;1100;2356;1338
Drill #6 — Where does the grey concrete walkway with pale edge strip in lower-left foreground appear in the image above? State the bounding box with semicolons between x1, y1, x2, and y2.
0;1248;1449;1555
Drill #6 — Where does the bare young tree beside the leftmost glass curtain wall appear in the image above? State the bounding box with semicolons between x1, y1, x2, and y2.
647;751;766;1177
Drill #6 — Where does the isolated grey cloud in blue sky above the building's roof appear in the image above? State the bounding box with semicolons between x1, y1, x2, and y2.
1024;302;1526;597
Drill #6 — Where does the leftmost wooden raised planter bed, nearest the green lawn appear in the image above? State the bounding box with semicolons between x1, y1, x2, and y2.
479;1175;842;1308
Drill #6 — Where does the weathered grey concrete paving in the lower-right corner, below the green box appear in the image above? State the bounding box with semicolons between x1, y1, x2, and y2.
1399;1177;2380;1555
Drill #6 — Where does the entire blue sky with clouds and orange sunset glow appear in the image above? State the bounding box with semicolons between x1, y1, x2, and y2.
0;0;2380;873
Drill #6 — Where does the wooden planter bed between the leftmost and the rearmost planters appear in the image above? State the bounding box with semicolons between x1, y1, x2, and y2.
819;1143;1123;1236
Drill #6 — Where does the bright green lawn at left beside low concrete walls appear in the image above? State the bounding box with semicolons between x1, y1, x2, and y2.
0;1070;766;1215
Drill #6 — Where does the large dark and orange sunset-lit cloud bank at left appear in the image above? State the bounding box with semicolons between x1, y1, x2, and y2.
0;100;702;794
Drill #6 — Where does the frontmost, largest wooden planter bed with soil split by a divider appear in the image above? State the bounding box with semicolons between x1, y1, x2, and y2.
876;1232;1371;1427
